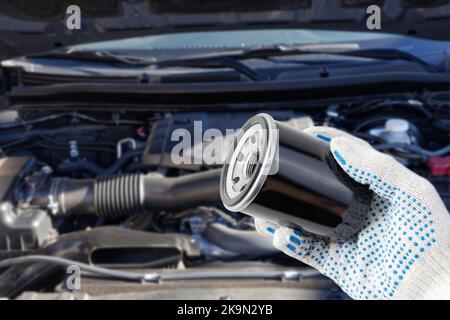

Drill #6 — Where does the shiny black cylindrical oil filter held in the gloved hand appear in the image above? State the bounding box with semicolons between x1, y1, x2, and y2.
220;114;373;240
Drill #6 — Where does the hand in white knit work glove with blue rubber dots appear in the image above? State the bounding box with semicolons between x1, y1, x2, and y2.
255;127;450;299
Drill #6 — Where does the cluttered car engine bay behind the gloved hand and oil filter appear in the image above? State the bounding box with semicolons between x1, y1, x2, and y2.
0;96;450;297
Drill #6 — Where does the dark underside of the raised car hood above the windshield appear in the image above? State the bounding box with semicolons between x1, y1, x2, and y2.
0;0;450;59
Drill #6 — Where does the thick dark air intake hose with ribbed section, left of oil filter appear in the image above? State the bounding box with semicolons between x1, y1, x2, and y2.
32;169;220;217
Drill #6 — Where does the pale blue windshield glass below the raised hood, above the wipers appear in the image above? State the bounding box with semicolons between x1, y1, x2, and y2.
69;29;450;68
